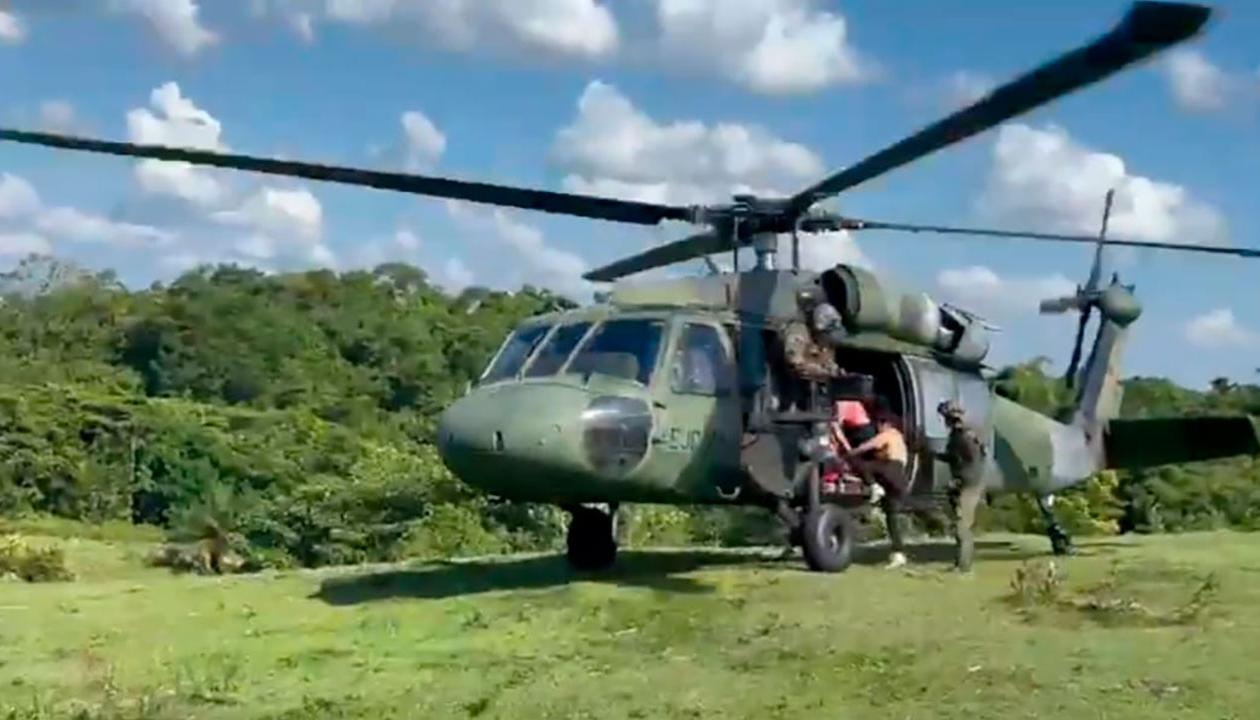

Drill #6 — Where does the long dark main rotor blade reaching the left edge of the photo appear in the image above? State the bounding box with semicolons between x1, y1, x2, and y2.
0;129;692;224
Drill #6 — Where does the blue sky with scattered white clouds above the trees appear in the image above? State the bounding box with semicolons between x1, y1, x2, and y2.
0;0;1260;386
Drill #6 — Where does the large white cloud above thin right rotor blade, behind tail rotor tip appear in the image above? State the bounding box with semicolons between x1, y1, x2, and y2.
979;124;1227;245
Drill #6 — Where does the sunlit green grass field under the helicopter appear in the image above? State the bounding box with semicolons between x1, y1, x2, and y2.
0;533;1260;720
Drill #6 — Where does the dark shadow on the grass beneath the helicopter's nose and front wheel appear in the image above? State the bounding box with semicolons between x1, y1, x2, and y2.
314;550;775;605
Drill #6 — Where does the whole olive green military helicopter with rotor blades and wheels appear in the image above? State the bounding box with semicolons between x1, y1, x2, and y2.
0;1;1260;571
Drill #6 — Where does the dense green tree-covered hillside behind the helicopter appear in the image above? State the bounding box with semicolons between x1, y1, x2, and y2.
0;258;1260;566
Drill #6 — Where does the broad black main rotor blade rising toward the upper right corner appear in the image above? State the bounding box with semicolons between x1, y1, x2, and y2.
789;1;1211;217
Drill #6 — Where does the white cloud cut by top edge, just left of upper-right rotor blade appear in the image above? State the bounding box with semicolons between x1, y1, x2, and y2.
655;0;873;95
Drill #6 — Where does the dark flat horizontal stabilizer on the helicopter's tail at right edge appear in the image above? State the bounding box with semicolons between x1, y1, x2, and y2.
1104;415;1260;470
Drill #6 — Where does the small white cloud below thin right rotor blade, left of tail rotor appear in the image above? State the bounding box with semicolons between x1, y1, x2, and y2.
936;265;1076;318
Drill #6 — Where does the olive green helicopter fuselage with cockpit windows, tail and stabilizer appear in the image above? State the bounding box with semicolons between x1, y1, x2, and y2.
438;266;1260;506
